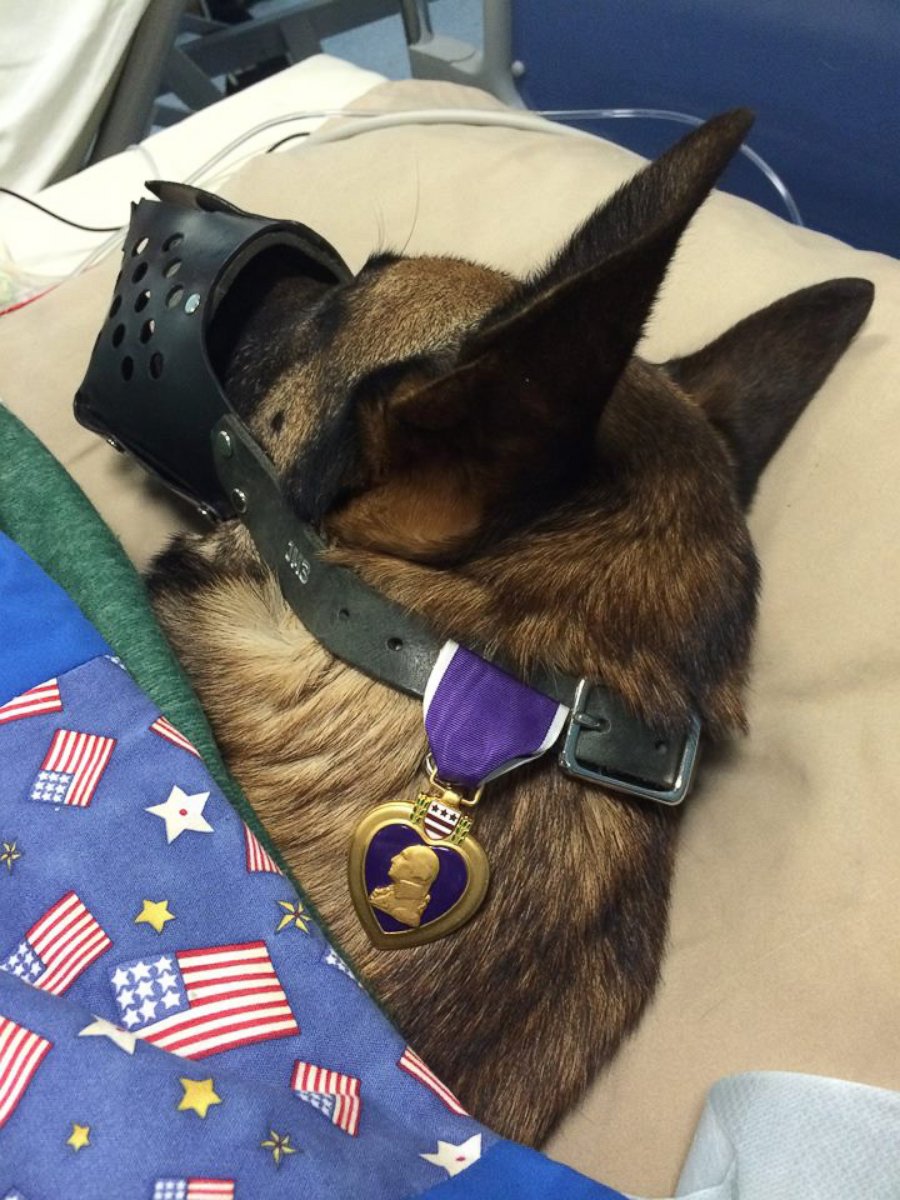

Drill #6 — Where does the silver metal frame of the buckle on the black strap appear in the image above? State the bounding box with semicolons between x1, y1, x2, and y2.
559;679;701;805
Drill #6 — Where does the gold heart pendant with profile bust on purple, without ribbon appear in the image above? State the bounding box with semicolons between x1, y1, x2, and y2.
349;791;490;950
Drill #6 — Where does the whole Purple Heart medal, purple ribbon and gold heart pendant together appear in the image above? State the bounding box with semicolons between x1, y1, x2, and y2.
349;642;569;949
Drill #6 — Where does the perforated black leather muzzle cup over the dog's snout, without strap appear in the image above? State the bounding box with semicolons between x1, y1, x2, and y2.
74;182;352;517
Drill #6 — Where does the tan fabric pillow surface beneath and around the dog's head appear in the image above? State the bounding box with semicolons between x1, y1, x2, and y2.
0;83;900;1194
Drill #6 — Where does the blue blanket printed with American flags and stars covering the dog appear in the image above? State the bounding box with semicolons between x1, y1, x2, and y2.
0;539;628;1200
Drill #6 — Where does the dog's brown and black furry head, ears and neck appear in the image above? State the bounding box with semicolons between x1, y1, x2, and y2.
150;112;872;1141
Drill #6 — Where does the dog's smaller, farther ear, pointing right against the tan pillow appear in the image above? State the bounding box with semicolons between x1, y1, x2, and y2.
666;278;875;505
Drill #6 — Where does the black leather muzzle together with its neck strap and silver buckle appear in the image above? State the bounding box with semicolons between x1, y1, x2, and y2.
74;184;700;804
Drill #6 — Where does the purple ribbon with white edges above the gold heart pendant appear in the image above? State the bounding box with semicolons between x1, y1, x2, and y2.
425;642;569;788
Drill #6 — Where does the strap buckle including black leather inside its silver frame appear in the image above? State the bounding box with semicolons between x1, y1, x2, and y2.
559;679;701;806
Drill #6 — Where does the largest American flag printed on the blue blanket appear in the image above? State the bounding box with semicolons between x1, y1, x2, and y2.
110;942;300;1058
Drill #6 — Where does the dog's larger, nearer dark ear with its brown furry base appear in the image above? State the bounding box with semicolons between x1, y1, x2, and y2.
331;109;752;556
